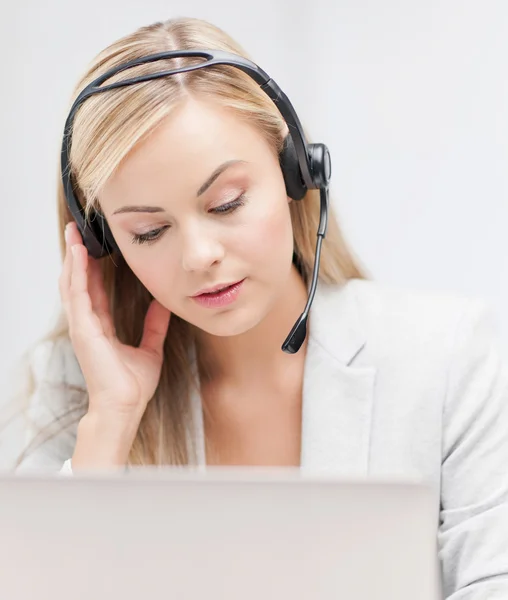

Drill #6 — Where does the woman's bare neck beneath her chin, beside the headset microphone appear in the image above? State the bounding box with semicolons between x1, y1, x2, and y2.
197;265;307;386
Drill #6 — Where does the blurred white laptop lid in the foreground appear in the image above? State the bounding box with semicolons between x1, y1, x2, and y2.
0;469;441;600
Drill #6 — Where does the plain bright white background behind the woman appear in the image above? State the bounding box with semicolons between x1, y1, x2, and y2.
0;0;508;424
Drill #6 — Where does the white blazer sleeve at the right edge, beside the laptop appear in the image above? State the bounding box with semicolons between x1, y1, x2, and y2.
438;300;508;600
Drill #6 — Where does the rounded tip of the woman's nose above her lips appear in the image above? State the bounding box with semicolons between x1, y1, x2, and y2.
181;225;224;272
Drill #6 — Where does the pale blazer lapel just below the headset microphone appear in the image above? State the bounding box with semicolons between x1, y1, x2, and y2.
301;282;376;476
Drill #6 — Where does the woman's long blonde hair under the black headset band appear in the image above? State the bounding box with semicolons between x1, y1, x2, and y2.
9;12;365;465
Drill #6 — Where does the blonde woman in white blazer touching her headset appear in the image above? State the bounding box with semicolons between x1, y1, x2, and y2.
13;19;508;600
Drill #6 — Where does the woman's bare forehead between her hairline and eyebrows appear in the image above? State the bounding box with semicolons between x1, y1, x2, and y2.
101;100;270;212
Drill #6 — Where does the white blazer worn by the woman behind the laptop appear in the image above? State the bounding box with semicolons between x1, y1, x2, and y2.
16;280;508;600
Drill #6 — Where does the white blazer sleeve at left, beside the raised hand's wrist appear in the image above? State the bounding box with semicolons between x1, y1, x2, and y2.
16;340;87;474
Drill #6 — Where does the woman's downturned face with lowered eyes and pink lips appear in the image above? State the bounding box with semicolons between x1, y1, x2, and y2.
99;100;293;336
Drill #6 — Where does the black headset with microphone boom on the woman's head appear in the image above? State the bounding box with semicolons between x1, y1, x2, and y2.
61;50;331;354
